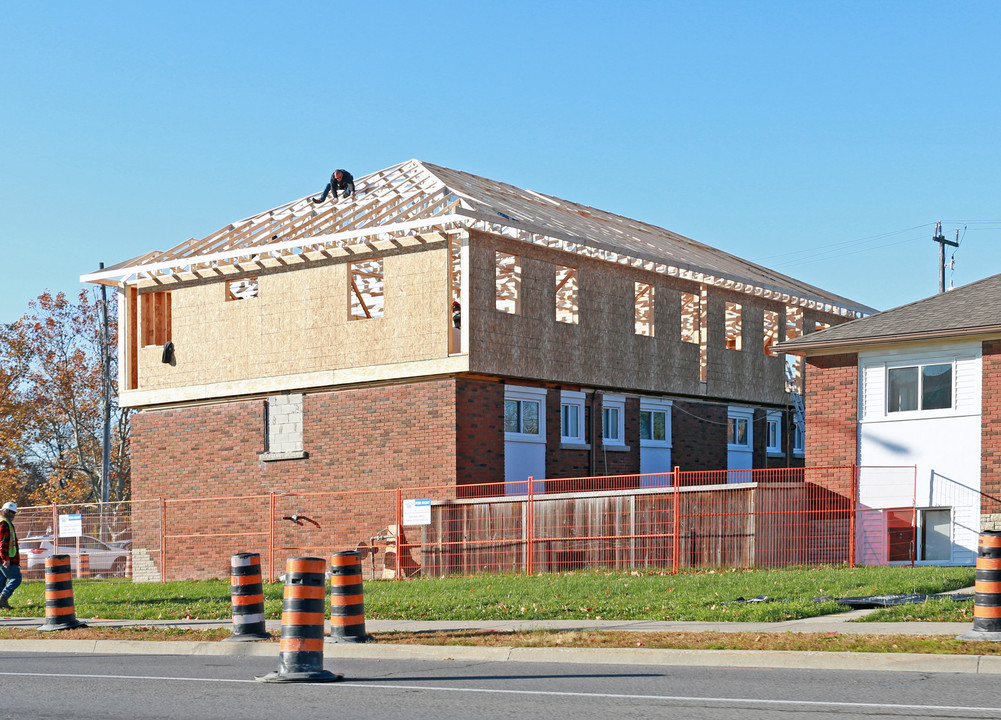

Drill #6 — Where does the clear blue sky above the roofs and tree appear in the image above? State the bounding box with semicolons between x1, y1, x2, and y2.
0;0;1001;322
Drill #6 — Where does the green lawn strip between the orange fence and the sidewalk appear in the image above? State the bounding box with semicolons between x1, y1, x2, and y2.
11;567;974;622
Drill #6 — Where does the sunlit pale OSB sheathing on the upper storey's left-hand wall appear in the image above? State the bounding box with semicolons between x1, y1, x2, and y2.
139;236;450;391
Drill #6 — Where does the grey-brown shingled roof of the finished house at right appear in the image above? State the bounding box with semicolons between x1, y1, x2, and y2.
775;274;1001;354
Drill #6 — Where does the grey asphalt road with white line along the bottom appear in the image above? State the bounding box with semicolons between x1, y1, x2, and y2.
0;652;1001;720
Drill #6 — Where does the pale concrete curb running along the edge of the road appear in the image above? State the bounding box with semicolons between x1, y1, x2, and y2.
0;639;1001;675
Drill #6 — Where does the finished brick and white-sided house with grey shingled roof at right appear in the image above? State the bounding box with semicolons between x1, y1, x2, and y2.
779;275;1001;565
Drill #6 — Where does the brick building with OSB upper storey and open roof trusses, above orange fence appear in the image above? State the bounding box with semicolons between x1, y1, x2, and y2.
83;160;870;524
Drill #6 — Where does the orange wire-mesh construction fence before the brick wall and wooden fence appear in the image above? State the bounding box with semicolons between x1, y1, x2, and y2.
18;466;914;582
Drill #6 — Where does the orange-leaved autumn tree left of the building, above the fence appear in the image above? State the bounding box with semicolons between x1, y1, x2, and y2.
0;290;129;505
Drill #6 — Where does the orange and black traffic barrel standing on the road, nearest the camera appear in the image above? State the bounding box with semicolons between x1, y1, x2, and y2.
256;558;343;683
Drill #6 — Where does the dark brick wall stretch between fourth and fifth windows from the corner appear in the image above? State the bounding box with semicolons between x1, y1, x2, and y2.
671;401;727;472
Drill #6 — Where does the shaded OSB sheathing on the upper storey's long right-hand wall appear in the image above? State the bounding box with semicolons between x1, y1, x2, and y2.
467;231;833;405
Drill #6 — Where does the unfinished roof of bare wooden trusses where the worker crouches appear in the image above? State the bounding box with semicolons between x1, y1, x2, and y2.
81;160;873;316
